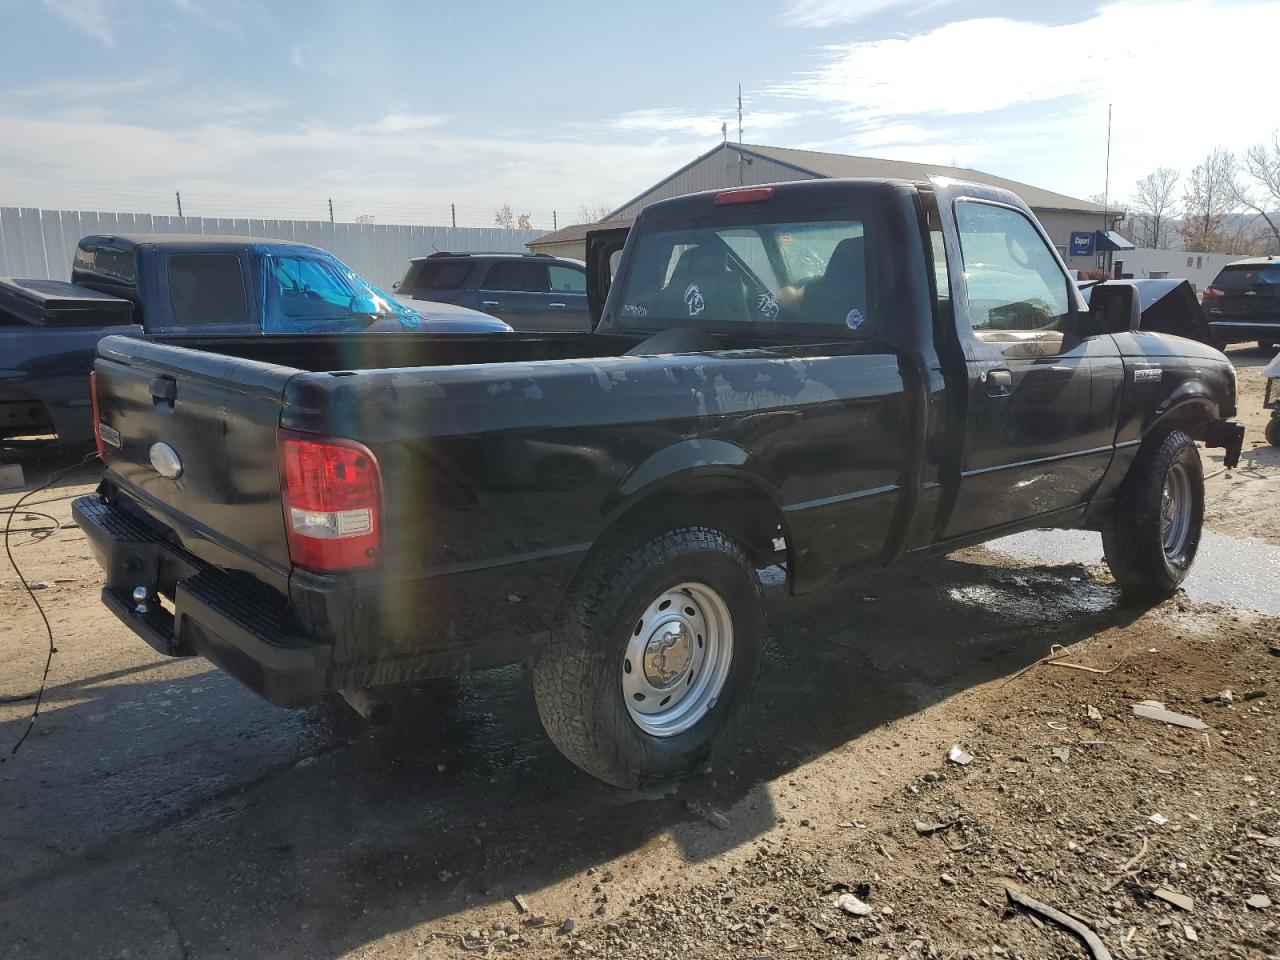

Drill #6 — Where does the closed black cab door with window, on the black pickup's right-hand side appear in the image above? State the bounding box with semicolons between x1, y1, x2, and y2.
942;188;1123;539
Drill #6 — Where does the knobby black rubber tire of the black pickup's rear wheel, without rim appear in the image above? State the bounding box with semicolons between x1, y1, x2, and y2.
534;525;764;788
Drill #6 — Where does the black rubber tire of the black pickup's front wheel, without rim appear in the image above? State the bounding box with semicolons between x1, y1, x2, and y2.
1102;430;1204;599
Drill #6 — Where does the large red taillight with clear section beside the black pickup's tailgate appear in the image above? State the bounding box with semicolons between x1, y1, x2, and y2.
279;430;383;571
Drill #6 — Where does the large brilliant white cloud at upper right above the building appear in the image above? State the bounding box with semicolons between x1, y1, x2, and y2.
772;0;1280;193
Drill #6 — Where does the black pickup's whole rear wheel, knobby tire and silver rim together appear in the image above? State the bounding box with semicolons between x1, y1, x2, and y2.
534;526;764;788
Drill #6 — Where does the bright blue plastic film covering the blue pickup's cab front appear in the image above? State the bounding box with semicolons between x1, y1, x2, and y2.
262;253;421;333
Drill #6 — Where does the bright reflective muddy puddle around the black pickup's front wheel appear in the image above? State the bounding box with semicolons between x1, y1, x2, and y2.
986;530;1280;614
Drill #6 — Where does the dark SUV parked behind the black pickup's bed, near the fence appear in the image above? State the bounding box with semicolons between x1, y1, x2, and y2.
396;252;591;330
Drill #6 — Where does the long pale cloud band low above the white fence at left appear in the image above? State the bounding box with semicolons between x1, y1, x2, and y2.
0;114;705;228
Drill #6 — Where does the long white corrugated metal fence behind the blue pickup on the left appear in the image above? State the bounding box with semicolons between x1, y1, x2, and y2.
0;206;545;289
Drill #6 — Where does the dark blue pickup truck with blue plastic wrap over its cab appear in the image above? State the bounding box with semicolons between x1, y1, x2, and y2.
0;236;511;447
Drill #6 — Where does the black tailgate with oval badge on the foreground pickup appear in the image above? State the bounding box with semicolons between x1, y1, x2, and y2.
95;337;298;591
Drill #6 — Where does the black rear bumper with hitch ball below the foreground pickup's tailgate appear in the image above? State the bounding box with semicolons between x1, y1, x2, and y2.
72;494;333;707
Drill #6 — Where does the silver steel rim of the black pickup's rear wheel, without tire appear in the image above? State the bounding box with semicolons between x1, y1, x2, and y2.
620;581;733;737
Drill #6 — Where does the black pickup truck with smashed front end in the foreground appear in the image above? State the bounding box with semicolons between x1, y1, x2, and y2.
74;179;1243;786
